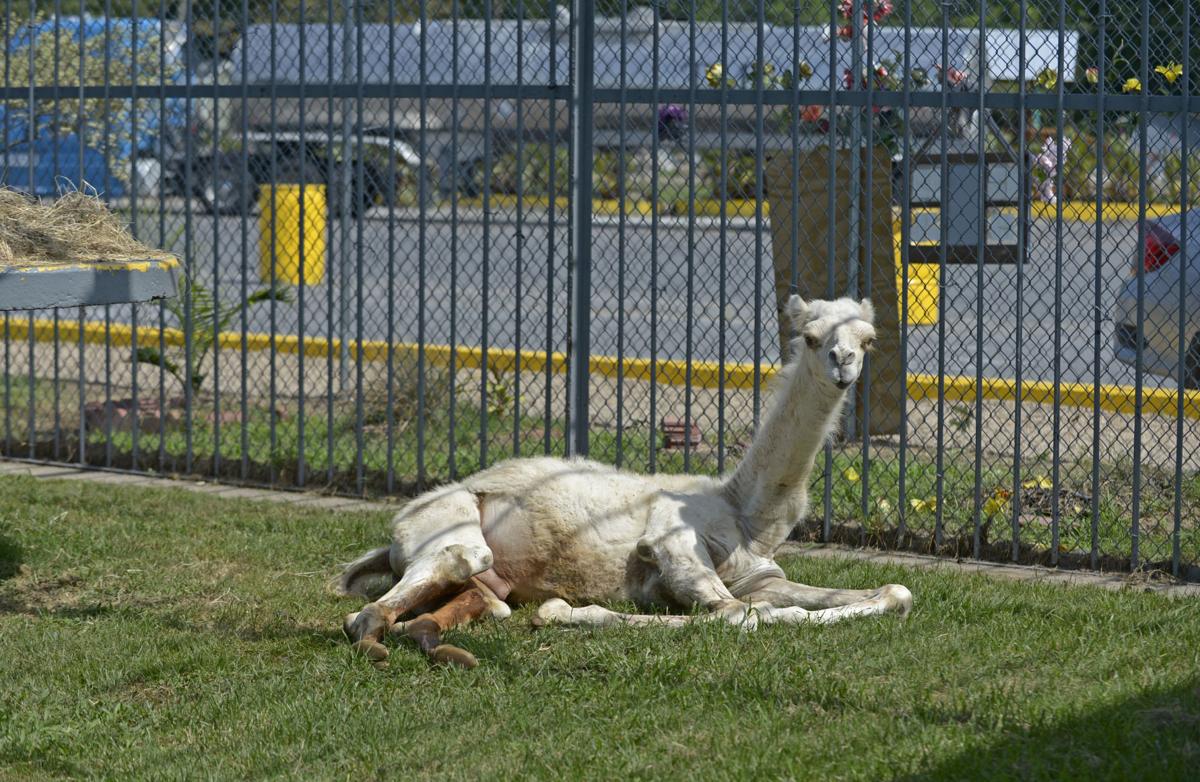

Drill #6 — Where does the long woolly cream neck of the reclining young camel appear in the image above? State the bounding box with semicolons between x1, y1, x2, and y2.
725;359;846;557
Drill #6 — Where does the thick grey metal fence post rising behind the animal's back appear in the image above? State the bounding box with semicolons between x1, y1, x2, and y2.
566;0;595;456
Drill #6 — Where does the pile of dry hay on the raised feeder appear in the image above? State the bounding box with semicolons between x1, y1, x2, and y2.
0;188;173;266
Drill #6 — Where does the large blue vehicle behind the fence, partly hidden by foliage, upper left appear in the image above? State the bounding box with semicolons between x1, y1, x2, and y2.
0;17;245;211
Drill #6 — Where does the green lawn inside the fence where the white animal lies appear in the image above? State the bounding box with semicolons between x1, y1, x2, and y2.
0;477;1200;780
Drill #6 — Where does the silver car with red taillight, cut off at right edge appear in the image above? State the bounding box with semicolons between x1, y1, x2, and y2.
1112;209;1200;389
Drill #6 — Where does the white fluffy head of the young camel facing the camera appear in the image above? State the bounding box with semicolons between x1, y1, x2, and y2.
785;296;875;390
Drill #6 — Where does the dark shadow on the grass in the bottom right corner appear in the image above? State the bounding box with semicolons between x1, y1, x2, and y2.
902;678;1200;781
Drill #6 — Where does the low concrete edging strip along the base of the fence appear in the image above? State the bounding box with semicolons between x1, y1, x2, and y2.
0;459;1200;597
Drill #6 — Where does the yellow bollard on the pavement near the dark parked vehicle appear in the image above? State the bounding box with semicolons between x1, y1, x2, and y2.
258;184;328;285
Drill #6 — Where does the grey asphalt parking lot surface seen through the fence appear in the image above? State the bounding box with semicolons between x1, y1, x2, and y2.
82;202;1170;385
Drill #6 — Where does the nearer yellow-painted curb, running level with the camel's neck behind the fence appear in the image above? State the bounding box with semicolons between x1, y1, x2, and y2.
8;318;1200;419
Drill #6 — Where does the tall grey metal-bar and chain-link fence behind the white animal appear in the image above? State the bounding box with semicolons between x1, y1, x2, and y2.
0;0;1200;578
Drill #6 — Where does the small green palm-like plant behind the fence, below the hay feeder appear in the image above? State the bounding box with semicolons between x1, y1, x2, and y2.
136;279;292;393
